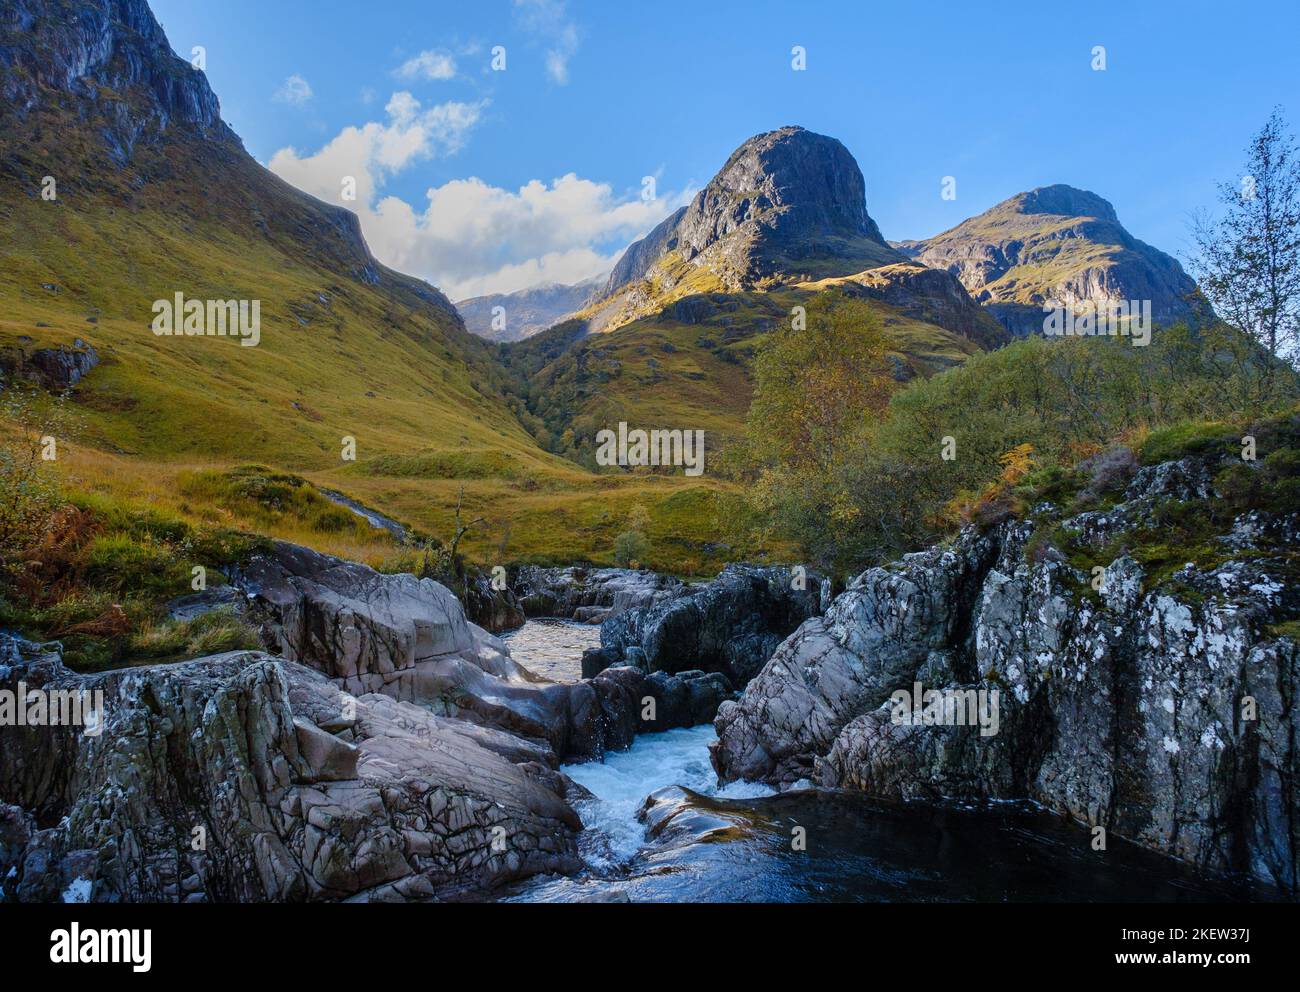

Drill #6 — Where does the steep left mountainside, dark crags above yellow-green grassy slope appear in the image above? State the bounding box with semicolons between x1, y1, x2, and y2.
0;0;537;468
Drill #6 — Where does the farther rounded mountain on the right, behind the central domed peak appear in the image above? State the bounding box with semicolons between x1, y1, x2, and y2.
894;185;1200;335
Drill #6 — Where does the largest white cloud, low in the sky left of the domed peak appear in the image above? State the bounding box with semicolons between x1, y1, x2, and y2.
270;100;690;299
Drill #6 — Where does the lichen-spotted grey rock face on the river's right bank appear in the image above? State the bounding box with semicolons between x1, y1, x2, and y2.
714;447;1300;889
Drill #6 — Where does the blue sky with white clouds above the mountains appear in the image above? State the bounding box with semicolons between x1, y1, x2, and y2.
151;0;1300;298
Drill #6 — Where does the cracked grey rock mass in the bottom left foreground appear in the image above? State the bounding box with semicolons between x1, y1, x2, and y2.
0;637;581;902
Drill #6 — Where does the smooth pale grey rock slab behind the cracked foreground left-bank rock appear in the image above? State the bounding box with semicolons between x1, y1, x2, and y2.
234;543;711;761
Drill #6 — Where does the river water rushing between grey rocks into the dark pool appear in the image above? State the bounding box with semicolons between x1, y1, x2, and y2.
493;620;1279;902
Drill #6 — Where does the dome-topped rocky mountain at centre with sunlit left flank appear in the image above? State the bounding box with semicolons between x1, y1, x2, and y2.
503;127;1010;456
